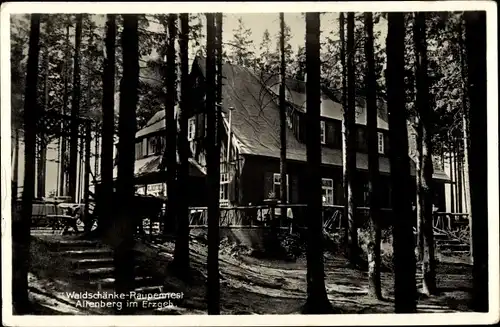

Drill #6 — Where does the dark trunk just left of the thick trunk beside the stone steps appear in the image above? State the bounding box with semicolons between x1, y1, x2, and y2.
96;14;116;237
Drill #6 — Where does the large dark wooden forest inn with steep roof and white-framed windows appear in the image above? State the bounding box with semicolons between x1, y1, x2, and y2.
120;57;448;210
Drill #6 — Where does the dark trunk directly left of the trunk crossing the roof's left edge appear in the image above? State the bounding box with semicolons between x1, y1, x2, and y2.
174;14;189;277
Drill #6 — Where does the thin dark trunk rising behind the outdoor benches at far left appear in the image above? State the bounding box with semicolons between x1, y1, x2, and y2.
68;14;83;202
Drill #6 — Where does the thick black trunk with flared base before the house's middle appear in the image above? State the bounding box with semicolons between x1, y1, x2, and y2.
303;13;333;314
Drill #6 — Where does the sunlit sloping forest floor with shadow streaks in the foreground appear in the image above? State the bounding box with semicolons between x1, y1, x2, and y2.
30;234;472;315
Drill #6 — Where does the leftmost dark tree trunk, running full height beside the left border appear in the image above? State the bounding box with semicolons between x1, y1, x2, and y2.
12;14;41;315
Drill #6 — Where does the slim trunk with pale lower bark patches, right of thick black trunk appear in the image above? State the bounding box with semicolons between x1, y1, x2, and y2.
413;12;436;295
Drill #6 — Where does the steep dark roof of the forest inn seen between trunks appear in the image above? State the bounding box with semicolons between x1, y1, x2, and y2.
195;57;448;179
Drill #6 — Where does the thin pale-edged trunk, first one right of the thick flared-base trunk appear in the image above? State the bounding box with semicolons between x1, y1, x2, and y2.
339;12;349;249
